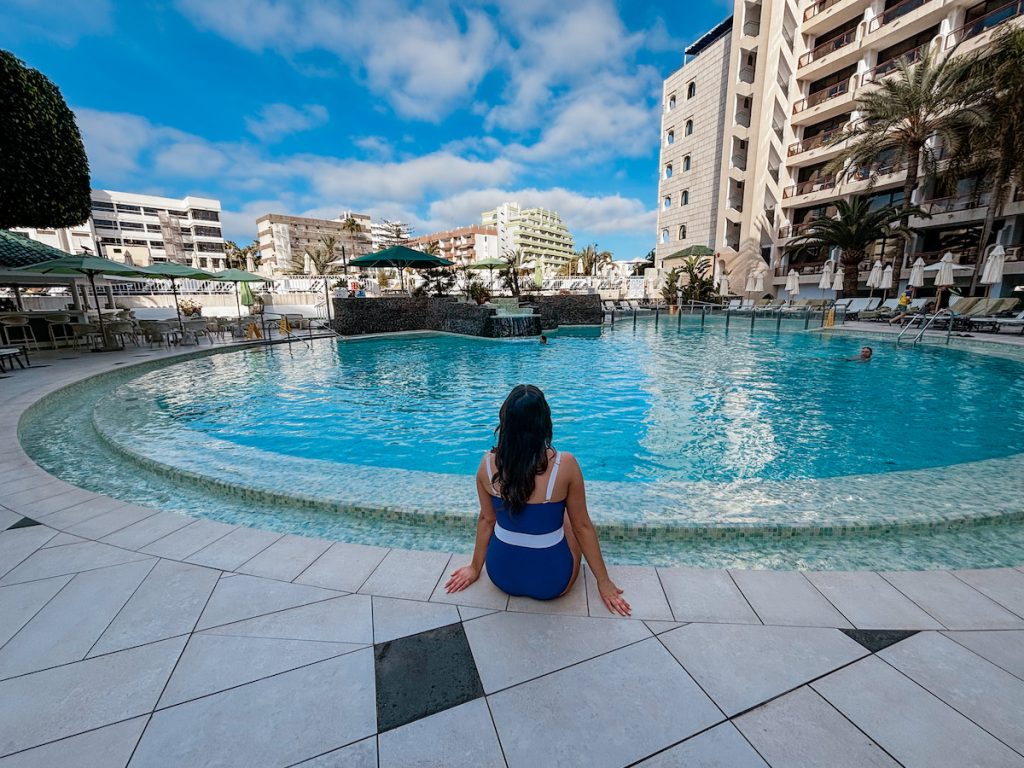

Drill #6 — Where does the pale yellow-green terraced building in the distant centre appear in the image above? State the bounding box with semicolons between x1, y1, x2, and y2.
480;203;574;270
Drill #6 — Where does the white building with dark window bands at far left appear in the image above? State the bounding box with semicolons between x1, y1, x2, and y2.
92;189;227;270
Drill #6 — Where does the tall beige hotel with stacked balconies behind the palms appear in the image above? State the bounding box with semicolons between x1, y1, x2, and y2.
657;0;1024;293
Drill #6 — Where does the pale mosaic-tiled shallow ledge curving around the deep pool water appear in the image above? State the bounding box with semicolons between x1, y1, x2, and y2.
19;337;1024;541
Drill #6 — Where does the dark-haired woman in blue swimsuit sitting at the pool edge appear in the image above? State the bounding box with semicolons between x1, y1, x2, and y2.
445;384;630;616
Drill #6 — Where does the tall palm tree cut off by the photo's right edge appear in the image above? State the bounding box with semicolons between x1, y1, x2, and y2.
952;27;1024;293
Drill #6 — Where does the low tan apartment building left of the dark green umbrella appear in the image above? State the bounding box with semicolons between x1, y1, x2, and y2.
256;211;372;274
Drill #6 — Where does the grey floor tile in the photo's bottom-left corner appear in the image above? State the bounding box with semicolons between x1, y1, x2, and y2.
0;717;148;768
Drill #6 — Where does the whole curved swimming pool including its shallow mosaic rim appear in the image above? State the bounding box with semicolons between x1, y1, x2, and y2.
23;321;1024;567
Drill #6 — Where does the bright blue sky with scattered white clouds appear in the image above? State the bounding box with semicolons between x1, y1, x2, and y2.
0;0;729;258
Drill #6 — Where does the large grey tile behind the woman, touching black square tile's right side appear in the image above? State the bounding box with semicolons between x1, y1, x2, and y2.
464;612;651;693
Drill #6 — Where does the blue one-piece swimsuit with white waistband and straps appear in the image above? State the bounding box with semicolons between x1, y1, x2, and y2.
486;452;574;600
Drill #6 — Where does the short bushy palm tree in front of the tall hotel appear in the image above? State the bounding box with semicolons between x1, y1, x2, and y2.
791;197;927;295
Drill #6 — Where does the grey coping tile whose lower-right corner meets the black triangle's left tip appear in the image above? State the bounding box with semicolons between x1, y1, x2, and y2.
729;570;851;627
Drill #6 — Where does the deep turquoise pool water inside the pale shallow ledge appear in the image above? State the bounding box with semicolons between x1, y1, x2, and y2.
144;323;1024;483
